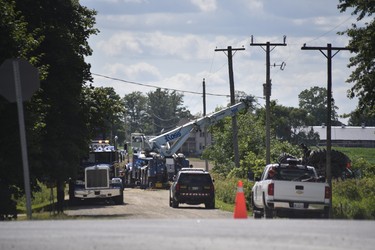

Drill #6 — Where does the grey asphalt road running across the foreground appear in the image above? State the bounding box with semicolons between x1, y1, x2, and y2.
0;219;375;250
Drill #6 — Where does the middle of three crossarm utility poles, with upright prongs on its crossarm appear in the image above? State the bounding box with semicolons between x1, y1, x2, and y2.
250;36;286;164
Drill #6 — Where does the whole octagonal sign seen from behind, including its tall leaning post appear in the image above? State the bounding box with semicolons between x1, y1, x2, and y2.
0;59;39;219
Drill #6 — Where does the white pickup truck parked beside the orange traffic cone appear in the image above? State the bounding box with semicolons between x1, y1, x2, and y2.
251;159;331;218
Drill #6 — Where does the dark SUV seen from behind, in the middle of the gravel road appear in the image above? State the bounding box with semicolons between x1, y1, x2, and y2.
169;168;215;209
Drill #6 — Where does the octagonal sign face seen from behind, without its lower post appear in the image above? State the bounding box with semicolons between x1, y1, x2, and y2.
0;59;39;102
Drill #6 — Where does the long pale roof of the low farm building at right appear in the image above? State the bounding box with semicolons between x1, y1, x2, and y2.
304;126;375;141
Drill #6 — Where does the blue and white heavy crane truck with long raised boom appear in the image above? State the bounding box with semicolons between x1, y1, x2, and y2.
128;97;253;187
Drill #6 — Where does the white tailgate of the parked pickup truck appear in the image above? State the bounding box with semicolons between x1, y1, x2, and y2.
273;181;325;202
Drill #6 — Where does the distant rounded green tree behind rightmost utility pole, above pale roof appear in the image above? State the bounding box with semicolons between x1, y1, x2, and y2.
298;86;341;126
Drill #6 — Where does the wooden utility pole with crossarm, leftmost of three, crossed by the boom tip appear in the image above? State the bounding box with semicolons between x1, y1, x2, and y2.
215;46;245;168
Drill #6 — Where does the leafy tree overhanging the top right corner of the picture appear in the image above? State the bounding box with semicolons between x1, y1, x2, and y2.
338;0;375;113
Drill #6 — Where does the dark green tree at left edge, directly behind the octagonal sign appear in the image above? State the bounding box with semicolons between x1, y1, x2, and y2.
0;0;45;220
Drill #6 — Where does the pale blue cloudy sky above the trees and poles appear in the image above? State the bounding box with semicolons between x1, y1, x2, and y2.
80;0;364;123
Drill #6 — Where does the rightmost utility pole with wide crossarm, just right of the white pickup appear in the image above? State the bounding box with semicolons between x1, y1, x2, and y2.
301;43;350;218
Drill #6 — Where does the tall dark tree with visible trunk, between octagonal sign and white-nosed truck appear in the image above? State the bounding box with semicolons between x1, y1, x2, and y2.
16;0;97;210
